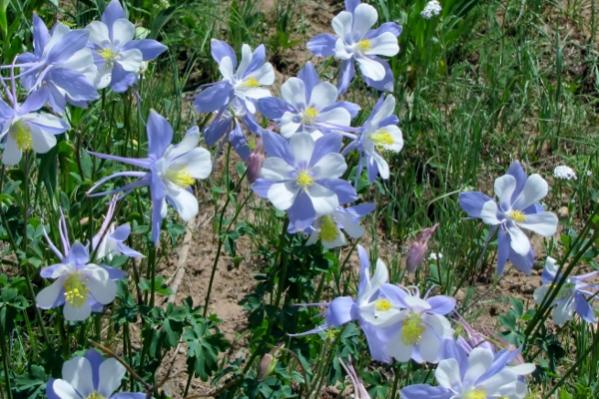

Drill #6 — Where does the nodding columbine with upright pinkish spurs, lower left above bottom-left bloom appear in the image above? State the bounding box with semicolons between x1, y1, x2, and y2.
35;215;124;321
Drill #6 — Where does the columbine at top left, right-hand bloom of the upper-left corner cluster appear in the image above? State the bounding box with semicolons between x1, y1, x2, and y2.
87;0;166;93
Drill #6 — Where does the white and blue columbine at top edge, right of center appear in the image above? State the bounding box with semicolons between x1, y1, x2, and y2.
308;0;401;93
